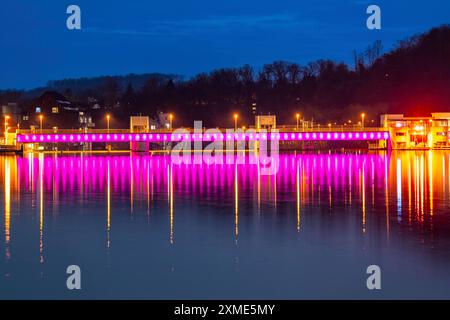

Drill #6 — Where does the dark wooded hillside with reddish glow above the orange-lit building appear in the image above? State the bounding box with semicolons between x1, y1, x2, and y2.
353;26;450;114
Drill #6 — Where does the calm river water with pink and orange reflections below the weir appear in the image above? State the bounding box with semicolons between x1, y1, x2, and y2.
0;152;450;299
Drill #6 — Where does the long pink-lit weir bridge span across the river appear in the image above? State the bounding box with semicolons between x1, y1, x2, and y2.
16;128;390;151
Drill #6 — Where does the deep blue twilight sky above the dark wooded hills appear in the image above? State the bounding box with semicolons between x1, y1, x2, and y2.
0;0;450;89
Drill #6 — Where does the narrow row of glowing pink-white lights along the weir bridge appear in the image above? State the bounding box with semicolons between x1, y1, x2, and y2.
17;132;389;143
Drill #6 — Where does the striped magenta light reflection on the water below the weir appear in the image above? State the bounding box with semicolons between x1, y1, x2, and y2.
17;154;387;202
